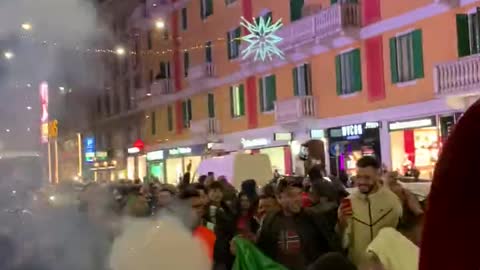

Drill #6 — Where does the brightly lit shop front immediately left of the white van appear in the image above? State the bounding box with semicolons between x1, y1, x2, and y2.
163;144;207;185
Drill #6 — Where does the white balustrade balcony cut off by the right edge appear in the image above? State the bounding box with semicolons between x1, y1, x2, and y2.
434;55;480;95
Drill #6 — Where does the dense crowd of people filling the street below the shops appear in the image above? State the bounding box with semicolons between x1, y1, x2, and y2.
82;157;423;270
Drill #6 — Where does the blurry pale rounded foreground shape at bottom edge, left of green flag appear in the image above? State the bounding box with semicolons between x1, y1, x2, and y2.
110;217;211;270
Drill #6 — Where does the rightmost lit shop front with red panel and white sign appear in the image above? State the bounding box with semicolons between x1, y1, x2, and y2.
388;114;461;179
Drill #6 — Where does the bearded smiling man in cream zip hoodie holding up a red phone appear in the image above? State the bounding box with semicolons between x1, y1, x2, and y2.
338;156;402;265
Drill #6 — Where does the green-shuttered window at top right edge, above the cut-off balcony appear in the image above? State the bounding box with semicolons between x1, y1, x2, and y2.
457;8;480;57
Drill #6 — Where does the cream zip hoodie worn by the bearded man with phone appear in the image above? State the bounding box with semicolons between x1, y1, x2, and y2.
344;187;402;265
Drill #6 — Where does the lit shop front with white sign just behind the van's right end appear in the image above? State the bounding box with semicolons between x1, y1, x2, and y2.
241;132;293;175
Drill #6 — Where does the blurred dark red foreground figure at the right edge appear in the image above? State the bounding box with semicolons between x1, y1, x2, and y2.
420;101;480;270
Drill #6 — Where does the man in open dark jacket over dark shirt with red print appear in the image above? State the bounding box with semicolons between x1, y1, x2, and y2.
257;180;340;270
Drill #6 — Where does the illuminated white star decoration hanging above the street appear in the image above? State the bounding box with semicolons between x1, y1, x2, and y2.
240;16;284;61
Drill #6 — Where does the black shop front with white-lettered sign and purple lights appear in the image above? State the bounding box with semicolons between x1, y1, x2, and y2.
326;122;381;175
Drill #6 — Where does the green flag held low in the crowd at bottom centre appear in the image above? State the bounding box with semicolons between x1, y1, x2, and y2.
232;237;288;270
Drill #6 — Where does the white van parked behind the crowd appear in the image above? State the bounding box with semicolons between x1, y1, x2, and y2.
195;153;273;188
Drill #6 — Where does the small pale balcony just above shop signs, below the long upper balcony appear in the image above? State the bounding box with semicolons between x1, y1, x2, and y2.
275;96;316;125
